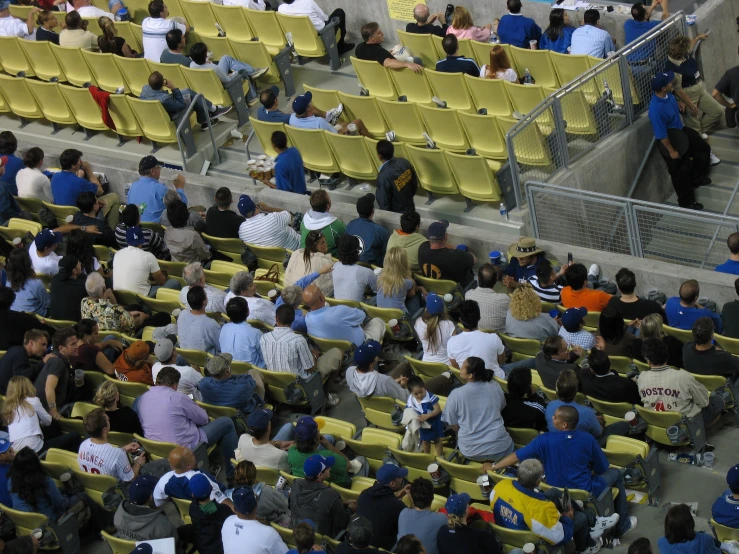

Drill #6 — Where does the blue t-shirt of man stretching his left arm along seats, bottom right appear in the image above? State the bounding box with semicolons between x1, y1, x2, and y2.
516;429;608;496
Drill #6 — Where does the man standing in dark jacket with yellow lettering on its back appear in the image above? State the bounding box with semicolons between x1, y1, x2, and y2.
376;140;416;213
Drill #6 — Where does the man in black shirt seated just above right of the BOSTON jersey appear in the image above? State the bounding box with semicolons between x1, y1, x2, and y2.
683;317;739;383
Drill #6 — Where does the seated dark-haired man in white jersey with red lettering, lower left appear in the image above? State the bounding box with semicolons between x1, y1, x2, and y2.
77;408;146;483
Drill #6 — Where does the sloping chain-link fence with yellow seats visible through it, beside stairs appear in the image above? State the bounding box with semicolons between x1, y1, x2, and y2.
506;12;686;206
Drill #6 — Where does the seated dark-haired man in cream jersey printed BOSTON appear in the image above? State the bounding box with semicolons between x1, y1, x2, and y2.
637;339;724;426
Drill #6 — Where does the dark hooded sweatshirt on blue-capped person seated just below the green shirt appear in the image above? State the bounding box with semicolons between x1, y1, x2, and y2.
290;479;348;536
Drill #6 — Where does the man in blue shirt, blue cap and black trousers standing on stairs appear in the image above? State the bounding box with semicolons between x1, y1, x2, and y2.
649;71;711;210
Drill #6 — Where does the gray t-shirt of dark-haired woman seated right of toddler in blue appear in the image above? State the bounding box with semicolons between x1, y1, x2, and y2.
441;381;513;460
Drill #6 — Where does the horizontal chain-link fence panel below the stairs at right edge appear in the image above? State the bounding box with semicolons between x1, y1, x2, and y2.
526;181;739;269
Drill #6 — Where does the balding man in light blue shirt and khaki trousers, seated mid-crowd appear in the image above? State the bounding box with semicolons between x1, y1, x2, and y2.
303;284;385;346
